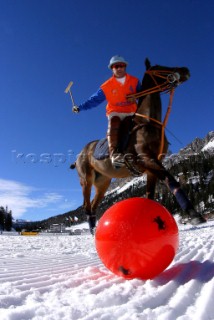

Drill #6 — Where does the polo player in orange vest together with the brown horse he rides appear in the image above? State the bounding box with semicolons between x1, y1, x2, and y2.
71;56;206;234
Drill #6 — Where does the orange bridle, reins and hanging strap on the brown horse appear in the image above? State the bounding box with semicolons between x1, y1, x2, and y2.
127;69;182;160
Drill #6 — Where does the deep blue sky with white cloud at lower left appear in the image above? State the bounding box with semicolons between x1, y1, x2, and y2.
0;0;214;220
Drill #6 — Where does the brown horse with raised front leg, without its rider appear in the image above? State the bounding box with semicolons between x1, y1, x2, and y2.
71;59;205;234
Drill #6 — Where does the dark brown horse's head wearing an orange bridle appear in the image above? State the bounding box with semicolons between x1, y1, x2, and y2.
142;59;190;92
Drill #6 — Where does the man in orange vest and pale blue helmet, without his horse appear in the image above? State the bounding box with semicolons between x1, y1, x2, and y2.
73;55;141;165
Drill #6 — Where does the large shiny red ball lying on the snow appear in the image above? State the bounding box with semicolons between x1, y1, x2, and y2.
95;198;179;280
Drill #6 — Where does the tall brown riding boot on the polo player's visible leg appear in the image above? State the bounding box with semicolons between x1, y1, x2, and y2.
107;116;124;165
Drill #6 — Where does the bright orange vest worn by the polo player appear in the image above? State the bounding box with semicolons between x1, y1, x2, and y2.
101;74;138;116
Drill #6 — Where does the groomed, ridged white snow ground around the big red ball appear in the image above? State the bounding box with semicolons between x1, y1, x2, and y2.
0;221;214;320
